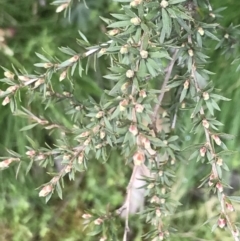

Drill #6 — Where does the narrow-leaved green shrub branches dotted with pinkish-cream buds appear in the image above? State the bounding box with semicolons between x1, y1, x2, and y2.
1;0;239;240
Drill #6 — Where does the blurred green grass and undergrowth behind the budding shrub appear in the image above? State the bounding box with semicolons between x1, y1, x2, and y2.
0;0;240;241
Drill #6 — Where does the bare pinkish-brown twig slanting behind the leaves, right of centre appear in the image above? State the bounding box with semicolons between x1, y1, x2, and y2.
152;49;178;129
